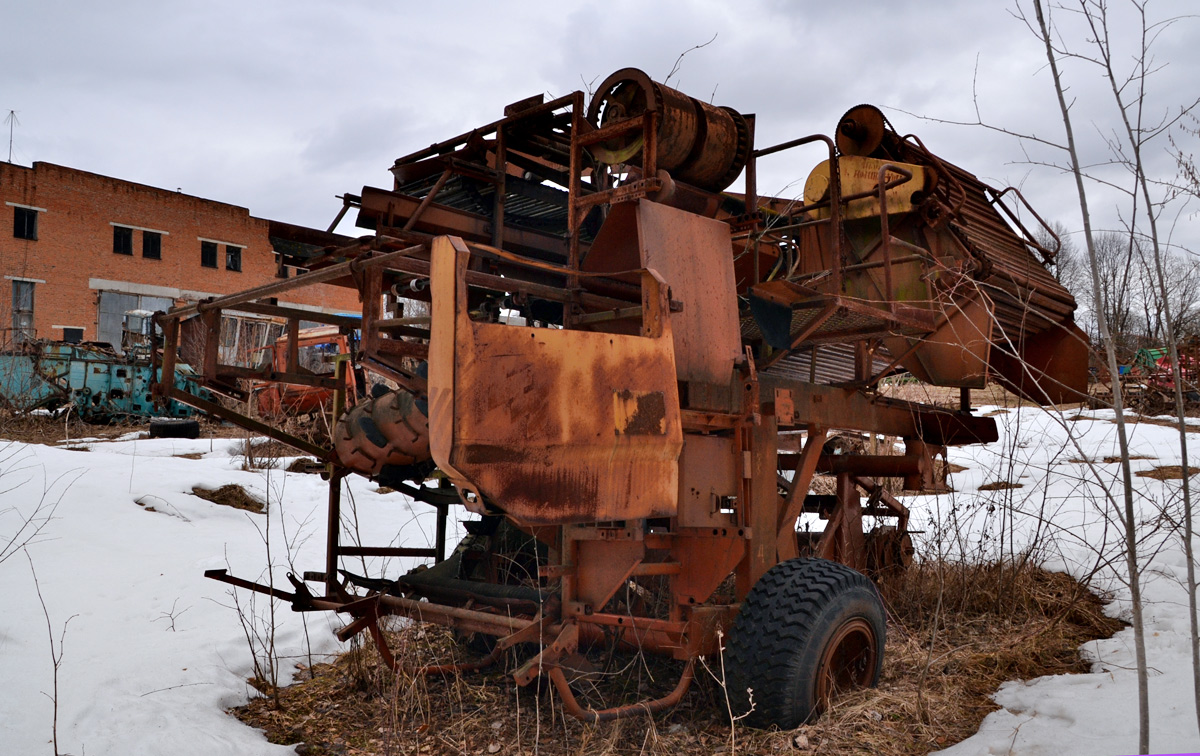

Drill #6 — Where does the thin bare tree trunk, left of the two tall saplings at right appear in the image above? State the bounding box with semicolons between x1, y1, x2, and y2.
1033;0;1150;754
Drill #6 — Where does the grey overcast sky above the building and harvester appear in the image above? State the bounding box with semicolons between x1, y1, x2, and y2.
0;0;1200;252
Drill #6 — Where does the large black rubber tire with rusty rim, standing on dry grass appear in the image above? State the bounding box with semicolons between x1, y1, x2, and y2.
725;559;886;730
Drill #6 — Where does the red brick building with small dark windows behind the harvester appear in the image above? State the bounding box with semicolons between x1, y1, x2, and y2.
0;162;360;352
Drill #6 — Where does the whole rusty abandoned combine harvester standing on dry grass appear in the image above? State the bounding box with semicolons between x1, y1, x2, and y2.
152;70;1087;727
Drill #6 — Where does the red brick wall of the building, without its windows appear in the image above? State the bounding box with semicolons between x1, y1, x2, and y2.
0;162;361;340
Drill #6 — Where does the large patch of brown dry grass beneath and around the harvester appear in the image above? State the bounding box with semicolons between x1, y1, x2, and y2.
233;565;1122;756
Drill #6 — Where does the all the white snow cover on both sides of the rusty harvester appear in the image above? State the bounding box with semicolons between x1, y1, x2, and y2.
0;409;1200;756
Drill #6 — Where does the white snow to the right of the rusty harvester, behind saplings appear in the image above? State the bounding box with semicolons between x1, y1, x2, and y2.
931;409;1200;756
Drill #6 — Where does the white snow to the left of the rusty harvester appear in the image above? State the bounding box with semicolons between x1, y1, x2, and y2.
0;434;463;756
